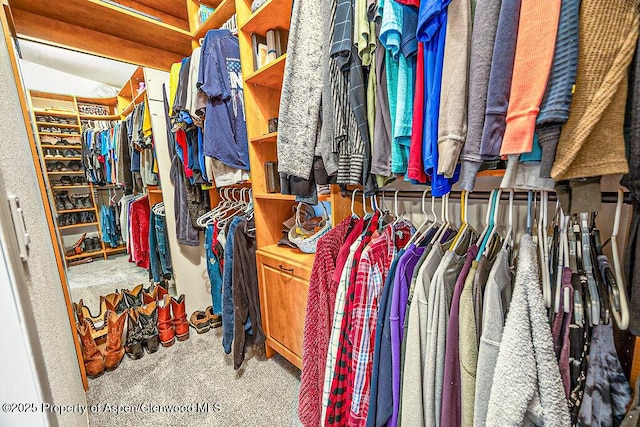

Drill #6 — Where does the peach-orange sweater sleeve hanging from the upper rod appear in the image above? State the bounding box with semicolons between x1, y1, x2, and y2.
500;0;561;155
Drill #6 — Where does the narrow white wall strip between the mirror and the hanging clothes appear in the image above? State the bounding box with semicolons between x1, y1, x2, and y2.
145;68;211;316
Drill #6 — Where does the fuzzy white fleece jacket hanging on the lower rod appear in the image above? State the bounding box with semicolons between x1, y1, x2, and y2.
487;234;571;427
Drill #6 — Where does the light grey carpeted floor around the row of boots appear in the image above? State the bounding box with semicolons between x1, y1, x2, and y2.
69;256;301;427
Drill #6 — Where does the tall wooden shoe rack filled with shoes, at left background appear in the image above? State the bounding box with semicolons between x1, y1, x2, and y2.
29;91;126;264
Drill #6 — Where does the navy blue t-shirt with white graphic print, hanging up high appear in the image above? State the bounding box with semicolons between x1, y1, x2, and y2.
198;30;249;170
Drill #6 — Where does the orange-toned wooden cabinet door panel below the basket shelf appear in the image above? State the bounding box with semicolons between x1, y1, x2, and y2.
260;259;309;358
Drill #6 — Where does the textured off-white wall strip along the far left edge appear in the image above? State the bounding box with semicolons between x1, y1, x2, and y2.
0;22;88;426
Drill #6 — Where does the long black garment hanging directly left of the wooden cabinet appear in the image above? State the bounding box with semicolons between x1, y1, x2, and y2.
232;220;266;369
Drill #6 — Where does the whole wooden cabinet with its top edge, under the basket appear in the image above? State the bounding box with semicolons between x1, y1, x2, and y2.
257;248;313;368
